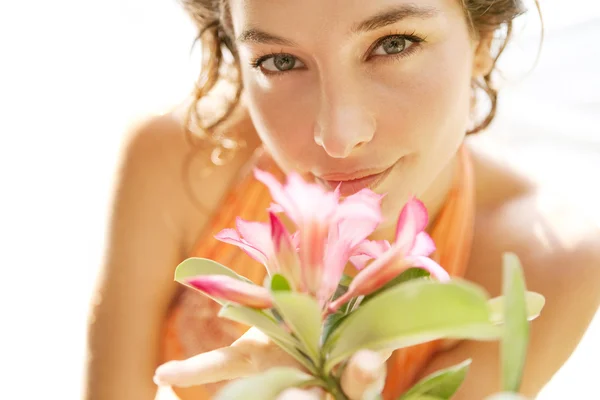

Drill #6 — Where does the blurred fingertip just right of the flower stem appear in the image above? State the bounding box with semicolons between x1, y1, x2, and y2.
341;350;391;400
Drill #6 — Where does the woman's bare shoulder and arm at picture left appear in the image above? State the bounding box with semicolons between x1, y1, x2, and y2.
86;108;260;399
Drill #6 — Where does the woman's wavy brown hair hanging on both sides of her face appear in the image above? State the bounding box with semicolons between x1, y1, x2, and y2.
180;0;539;165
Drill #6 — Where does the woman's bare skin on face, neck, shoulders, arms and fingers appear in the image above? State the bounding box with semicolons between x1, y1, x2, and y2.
86;0;600;399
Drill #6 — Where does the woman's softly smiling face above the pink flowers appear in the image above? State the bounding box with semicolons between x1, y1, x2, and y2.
230;0;476;222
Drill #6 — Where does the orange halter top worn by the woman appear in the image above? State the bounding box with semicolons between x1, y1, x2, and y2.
163;146;475;400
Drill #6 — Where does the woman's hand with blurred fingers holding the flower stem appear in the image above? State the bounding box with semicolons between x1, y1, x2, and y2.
154;328;391;400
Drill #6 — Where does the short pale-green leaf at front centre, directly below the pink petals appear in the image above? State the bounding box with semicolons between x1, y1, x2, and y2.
273;292;321;363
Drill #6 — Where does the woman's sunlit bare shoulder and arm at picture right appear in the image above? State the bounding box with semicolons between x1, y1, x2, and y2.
428;143;600;399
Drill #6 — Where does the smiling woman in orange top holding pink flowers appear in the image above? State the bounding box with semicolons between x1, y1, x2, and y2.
87;0;600;400
